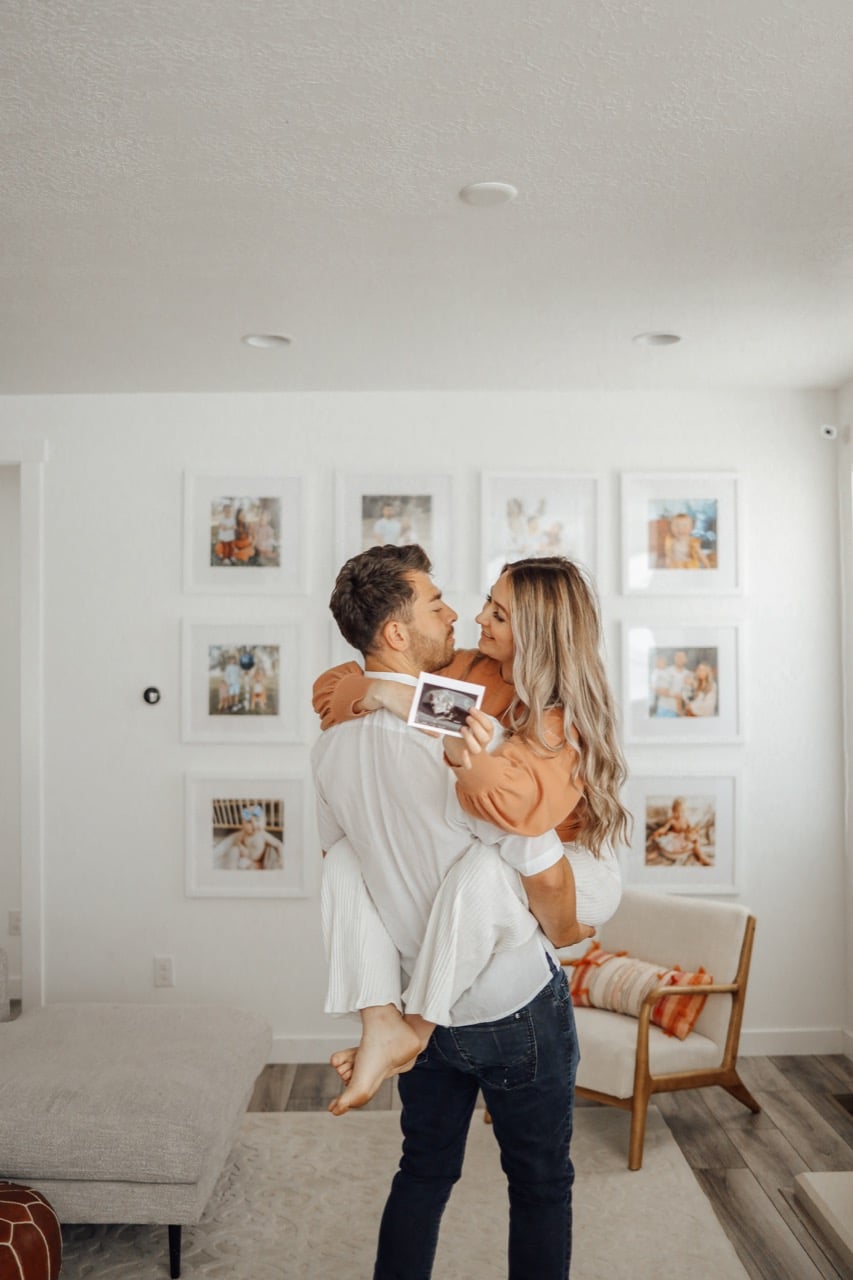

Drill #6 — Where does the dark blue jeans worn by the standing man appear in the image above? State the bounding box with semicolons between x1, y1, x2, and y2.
373;970;579;1280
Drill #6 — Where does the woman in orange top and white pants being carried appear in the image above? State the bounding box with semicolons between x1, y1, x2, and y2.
314;557;628;1114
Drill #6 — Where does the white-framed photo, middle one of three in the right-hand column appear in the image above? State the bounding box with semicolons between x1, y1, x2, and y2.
622;623;743;742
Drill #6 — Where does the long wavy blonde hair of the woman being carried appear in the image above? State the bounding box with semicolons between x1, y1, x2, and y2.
494;556;631;858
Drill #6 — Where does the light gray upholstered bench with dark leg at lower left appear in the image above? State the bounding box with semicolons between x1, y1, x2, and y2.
0;1005;272;1276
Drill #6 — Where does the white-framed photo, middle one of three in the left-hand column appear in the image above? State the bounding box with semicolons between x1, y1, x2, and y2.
182;620;307;742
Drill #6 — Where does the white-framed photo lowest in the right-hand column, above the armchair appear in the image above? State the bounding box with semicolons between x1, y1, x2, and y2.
622;773;738;893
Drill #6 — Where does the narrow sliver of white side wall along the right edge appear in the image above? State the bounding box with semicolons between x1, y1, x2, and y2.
835;383;853;1057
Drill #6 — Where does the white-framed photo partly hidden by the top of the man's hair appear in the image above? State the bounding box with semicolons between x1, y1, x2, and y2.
336;472;457;588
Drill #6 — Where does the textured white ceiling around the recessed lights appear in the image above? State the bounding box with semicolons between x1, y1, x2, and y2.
0;0;853;393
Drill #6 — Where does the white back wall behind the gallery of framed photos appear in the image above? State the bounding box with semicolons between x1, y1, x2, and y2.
0;393;849;1061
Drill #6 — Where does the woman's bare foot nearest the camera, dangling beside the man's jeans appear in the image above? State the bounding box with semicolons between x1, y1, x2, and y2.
329;1005;421;1116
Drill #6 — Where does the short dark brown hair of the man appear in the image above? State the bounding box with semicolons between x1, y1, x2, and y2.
329;543;432;654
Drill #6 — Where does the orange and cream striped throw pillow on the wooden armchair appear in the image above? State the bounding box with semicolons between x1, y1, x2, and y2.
569;942;713;1039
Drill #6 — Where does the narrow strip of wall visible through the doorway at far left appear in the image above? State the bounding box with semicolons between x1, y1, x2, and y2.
0;466;20;997
